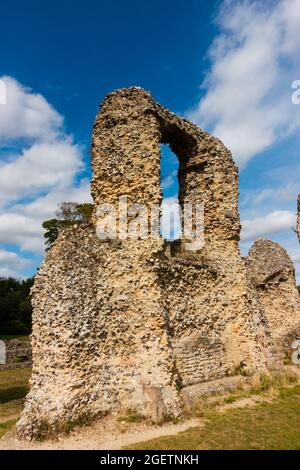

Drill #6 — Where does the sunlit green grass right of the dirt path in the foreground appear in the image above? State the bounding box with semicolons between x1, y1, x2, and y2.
128;385;300;450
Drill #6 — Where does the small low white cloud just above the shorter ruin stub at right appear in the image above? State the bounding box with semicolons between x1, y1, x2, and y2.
241;211;296;242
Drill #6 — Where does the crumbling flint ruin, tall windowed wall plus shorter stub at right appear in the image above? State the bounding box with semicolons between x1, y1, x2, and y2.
18;87;300;439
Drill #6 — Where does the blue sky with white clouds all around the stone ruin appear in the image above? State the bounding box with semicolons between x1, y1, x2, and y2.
0;0;300;276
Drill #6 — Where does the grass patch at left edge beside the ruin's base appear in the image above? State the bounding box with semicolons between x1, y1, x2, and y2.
0;368;31;438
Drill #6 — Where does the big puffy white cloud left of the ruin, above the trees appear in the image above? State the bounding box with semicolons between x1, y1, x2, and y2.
0;76;91;275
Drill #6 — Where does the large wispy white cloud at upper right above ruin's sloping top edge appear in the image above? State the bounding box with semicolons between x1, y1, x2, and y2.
188;0;300;166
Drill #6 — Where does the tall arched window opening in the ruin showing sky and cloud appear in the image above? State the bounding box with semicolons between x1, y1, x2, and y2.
160;144;181;241
